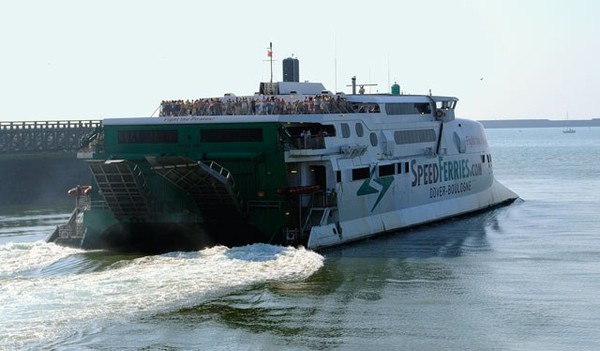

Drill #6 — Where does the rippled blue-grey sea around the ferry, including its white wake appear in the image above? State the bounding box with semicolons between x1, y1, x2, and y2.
0;128;600;350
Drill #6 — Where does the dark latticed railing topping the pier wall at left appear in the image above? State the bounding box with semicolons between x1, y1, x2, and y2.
0;120;102;155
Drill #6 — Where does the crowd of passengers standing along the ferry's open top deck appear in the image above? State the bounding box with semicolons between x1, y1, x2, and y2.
160;95;379;117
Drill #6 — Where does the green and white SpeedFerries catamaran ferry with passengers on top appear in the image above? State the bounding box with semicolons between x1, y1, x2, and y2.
47;64;518;253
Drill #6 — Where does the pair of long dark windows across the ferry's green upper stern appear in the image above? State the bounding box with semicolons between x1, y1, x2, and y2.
117;128;263;144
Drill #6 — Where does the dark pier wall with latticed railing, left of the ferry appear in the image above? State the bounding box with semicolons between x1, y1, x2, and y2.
0;120;102;206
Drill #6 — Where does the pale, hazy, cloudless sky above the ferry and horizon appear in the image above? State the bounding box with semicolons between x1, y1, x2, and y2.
0;0;600;121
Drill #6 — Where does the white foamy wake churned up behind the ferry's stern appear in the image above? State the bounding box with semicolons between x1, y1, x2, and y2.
0;243;324;349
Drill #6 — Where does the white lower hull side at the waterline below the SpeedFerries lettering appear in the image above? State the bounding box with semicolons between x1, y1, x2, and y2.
307;179;518;250
